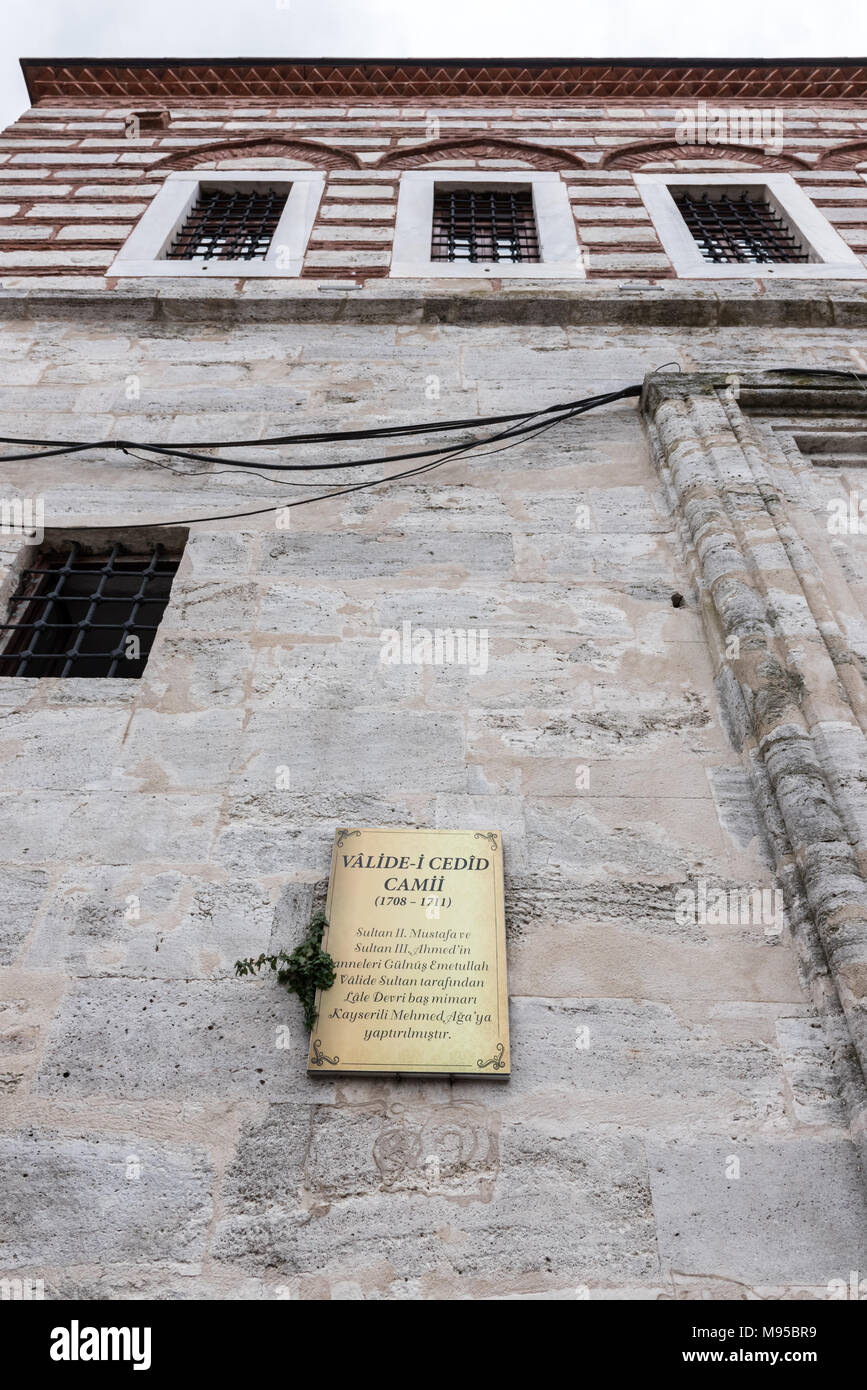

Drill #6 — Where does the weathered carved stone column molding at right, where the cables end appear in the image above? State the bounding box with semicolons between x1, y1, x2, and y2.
641;373;867;1154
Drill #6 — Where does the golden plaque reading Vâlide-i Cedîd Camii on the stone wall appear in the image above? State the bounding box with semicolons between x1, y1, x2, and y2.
307;828;509;1079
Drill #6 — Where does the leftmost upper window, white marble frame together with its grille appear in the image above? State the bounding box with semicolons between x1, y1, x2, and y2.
108;170;325;278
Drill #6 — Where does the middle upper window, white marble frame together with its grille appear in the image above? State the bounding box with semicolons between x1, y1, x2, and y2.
390;168;585;278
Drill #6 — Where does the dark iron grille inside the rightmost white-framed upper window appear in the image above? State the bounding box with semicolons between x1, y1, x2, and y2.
674;192;810;265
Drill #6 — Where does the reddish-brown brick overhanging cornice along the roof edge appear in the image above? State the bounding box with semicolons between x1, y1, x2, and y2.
21;58;867;106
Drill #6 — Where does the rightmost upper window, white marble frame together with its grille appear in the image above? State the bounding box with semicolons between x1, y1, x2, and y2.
635;174;867;279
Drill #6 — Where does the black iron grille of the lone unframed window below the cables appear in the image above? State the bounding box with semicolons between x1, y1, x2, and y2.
0;543;178;677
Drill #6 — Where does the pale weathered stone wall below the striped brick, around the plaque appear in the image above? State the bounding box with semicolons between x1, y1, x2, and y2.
0;301;867;1298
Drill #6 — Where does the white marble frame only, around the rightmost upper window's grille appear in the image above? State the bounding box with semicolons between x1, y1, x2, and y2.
635;170;867;279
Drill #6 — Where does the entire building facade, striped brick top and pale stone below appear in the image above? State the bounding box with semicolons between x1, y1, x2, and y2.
0;60;867;1300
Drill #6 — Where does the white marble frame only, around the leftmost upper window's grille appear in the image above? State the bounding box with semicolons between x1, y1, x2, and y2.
106;168;325;279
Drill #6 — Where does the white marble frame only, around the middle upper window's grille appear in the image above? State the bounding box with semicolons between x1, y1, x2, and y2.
389;167;586;279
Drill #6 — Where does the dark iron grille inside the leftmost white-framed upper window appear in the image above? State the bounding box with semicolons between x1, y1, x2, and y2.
165;186;289;261
